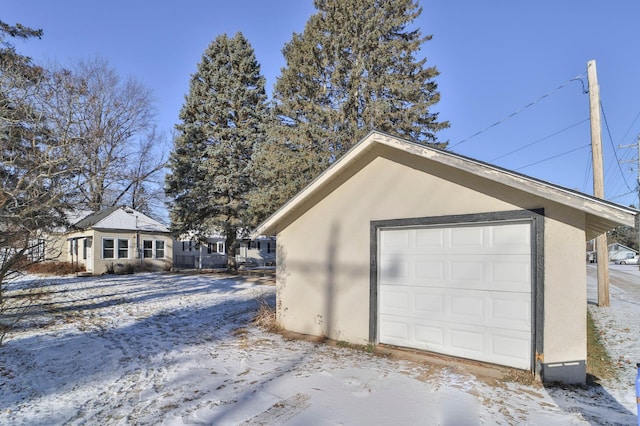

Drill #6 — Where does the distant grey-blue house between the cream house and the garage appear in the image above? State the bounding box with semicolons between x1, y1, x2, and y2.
173;235;227;269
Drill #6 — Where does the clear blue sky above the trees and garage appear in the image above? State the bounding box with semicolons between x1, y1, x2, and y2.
5;0;640;209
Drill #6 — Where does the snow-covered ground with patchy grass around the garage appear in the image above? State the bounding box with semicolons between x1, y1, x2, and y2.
0;267;640;425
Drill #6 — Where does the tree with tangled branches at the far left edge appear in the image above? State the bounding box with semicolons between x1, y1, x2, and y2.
0;21;76;300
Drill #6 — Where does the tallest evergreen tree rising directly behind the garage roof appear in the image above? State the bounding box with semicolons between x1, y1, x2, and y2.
251;0;449;220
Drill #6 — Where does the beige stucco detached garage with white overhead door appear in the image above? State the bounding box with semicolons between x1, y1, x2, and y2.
253;132;638;383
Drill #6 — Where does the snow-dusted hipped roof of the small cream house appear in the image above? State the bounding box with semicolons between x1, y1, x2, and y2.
73;207;169;233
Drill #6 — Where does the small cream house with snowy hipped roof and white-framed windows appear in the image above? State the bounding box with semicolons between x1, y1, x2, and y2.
58;207;173;275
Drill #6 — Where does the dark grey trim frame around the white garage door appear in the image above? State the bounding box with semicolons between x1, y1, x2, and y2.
369;209;544;373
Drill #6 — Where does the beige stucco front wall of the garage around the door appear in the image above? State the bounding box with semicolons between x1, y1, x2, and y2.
277;152;586;368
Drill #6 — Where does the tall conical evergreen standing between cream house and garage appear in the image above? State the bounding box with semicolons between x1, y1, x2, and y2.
165;33;268;266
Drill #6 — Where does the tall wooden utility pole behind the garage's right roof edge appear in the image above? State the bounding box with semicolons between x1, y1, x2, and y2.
587;60;609;307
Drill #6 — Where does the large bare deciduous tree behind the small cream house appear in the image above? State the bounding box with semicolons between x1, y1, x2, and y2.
50;59;167;213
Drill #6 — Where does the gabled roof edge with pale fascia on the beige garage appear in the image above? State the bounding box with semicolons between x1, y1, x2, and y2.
252;131;639;239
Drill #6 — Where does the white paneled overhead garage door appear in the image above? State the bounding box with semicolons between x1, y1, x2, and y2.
378;222;532;369
